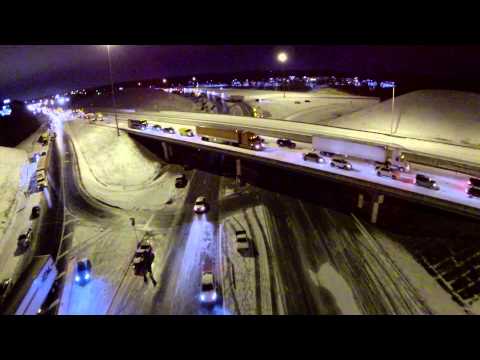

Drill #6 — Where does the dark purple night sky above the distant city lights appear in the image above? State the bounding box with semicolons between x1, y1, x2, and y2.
0;45;480;99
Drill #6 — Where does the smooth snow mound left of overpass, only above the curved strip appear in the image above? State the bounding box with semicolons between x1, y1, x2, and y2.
69;122;161;190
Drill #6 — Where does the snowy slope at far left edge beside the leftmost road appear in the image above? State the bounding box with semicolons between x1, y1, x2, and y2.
0;147;28;239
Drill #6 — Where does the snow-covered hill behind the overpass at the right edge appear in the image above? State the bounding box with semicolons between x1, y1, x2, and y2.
328;90;480;148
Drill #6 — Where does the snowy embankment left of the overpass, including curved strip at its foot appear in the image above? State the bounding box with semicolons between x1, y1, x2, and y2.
66;121;173;209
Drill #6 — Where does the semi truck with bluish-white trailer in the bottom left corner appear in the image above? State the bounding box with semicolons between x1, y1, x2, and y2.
1;255;58;315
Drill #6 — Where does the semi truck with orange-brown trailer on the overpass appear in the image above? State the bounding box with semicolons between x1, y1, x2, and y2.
197;127;263;151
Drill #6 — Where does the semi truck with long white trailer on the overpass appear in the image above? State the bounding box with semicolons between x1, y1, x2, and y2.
312;136;410;172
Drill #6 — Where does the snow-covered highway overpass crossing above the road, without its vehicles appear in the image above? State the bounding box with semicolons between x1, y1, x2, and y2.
77;109;480;217
